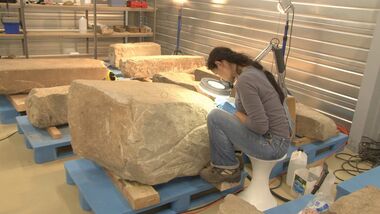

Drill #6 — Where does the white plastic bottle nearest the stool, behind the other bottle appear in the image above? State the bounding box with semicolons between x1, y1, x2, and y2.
286;149;307;186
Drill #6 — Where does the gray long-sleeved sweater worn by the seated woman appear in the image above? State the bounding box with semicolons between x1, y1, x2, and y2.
235;66;289;138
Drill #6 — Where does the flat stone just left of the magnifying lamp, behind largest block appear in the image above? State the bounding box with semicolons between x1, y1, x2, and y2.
153;72;199;91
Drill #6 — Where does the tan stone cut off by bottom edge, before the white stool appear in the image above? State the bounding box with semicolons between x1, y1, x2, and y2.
218;194;263;214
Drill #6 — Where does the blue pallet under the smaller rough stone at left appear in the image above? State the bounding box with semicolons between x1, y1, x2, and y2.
16;116;73;163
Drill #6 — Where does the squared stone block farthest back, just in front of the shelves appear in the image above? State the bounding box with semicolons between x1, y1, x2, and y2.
108;42;161;68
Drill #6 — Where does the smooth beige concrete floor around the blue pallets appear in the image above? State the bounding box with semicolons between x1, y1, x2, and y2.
0;123;356;214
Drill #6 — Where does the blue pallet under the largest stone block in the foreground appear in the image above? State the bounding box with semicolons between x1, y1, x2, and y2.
65;159;246;214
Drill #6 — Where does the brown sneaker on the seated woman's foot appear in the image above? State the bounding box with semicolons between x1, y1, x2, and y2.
200;166;241;184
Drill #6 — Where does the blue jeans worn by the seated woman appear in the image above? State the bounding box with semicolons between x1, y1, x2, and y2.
207;109;290;169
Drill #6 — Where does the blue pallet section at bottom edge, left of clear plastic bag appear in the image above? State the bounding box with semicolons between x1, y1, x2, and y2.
264;195;314;214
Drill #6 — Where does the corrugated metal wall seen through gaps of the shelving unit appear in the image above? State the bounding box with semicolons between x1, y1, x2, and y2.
0;1;152;57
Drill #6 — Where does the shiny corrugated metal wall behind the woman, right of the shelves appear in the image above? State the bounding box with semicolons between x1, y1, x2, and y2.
156;0;380;127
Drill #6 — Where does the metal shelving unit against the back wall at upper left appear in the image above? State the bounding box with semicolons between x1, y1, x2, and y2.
0;0;157;59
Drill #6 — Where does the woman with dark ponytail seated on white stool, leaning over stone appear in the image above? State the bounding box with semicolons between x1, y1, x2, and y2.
200;47;290;183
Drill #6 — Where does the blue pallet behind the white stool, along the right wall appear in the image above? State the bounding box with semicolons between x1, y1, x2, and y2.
270;133;348;178
